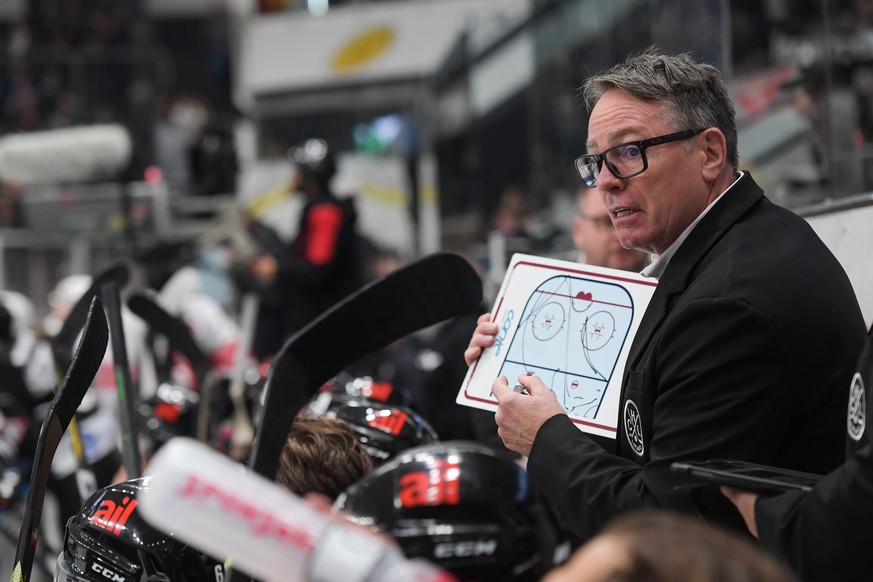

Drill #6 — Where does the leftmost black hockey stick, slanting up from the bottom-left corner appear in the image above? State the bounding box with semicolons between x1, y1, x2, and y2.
11;297;109;582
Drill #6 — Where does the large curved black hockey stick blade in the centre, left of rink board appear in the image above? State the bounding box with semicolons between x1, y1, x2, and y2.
249;253;482;480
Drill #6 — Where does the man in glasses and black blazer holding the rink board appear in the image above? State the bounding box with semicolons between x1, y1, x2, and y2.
465;50;865;538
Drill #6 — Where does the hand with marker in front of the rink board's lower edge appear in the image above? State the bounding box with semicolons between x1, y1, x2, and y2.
490;374;567;456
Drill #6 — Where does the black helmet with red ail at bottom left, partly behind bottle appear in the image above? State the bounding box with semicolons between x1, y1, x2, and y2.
55;477;226;582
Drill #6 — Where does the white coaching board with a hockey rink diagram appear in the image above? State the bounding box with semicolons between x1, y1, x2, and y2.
456;254;657;438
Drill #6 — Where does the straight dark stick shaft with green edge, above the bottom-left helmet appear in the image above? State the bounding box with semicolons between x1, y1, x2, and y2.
100;283;142;479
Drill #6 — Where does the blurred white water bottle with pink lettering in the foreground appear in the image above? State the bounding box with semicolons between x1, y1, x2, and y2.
136;438;454;582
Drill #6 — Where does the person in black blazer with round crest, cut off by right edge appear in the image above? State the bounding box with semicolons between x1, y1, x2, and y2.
723;329;873;582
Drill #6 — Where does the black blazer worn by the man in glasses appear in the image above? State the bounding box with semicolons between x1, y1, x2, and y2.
528;173;865;539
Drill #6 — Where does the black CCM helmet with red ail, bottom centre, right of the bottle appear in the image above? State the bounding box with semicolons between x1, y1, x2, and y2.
335;441;558;581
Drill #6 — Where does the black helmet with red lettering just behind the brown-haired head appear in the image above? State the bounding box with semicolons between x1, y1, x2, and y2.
306;392;439;465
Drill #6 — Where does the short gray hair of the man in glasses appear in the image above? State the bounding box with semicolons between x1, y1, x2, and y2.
581;47;739;169
